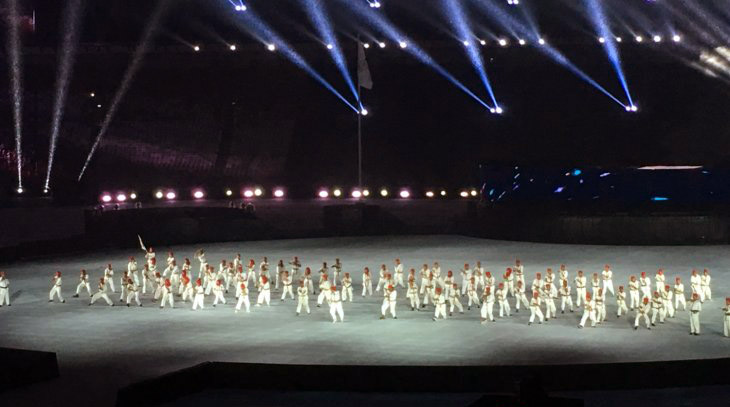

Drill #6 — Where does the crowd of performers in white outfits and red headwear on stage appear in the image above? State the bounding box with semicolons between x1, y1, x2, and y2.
0;248;730;337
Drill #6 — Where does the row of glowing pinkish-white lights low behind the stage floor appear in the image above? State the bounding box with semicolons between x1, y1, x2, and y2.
99;187;479;203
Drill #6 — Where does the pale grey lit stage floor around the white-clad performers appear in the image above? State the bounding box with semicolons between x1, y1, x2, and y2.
0;236;730;405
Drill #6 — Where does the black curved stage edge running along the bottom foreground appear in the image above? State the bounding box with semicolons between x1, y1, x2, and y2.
117;358;730;407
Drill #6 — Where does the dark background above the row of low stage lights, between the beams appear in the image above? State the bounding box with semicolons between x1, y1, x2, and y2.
0;0;730;199
